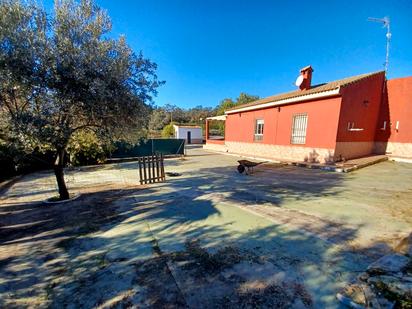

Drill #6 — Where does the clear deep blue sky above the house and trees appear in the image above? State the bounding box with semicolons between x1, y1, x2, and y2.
45;0;412;108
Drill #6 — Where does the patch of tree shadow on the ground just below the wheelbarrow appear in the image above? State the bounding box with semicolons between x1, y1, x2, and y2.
161;165;347;206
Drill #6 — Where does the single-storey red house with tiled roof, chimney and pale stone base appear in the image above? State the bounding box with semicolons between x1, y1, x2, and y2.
204;66;412;163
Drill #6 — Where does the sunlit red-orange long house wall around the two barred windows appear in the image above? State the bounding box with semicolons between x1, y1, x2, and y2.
225;97;341;149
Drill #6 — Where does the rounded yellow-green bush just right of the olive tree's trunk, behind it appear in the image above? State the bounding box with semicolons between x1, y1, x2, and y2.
67;131;106;166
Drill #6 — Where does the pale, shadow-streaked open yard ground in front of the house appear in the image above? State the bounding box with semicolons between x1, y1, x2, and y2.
0;148;412;308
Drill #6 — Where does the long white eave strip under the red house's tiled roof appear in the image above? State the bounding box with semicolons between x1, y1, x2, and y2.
225;87;340;115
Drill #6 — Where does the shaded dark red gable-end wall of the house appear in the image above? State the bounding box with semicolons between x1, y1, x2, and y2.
336;72;385;142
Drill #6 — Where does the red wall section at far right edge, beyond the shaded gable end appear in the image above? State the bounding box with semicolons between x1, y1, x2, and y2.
376;76;412;143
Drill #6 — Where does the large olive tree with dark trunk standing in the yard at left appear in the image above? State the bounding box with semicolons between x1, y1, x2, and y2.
0;0;162;199
